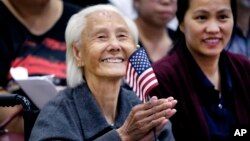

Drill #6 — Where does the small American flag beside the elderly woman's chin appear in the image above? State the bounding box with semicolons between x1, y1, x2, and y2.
125;47;158;102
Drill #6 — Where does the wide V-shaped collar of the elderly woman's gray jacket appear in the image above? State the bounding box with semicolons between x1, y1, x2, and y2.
73;83;131;140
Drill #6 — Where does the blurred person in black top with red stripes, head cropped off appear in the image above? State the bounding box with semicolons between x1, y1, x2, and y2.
0;0;80;132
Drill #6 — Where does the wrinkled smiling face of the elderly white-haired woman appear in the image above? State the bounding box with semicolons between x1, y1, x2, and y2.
75;11;136;79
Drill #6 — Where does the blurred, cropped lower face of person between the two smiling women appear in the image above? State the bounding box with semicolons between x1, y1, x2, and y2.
134;0;177;26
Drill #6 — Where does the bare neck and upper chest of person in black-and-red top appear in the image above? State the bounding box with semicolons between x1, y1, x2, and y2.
2;0;63;35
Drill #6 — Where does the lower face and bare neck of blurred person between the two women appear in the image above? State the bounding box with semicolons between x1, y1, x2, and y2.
133;0;177;63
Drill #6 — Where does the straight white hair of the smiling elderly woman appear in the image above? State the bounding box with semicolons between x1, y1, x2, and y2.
65;4;138;87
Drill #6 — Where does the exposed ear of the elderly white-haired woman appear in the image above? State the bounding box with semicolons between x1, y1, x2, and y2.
72;42;84;67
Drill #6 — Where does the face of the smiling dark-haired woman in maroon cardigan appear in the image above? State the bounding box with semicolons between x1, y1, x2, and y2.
180;0;233;57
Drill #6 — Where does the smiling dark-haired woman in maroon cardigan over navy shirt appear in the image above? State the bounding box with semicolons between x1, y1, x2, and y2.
149;0;250;141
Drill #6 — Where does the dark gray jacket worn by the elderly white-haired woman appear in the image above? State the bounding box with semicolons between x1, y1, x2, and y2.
29;84;174;141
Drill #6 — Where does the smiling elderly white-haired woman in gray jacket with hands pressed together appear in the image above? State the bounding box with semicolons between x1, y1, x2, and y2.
30;5;177;141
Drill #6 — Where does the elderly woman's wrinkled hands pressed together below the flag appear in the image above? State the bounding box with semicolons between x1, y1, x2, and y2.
117;96;177;141
